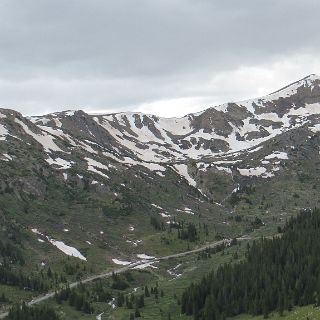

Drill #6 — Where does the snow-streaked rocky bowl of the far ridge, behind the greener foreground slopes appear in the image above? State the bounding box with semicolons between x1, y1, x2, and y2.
26;75;320;165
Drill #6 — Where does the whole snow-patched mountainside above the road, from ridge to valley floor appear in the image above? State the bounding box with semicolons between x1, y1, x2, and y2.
0;75;320;280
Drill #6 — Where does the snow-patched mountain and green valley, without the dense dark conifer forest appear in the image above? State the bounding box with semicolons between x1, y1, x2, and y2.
0;75;320;320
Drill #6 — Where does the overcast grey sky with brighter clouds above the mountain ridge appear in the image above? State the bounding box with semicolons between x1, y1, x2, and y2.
0;0;320;117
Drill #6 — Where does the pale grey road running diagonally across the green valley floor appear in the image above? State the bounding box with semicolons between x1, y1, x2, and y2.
0;238;231;319
